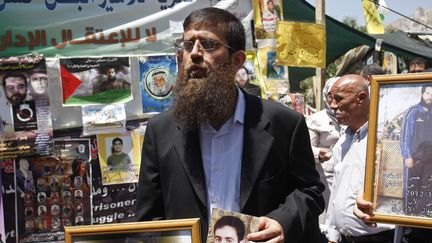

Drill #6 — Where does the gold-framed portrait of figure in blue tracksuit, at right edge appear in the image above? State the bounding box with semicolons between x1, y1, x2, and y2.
364;73;432;227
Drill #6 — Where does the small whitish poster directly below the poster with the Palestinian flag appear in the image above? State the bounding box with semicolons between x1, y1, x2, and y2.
81;104;126;135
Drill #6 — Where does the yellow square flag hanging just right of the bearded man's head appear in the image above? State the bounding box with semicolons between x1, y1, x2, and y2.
276;21;326;68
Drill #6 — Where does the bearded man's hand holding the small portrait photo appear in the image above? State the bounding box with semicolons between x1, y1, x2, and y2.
247;217;285;243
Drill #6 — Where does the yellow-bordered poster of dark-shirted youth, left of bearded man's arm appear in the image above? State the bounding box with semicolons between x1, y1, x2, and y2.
96;130;141;185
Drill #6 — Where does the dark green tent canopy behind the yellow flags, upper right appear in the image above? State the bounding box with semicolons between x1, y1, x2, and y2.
283;0;432;91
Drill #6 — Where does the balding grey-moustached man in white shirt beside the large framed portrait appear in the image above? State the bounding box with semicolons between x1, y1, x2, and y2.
327;74;394;243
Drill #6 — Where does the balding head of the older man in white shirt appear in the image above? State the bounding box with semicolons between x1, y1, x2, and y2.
330;74;369;131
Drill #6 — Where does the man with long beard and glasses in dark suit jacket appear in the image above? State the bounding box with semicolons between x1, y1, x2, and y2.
136;8;324;242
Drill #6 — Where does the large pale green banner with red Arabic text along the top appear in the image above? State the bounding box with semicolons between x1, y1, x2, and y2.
0;0;252;57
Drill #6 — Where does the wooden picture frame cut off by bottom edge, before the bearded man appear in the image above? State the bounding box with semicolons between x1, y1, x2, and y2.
65;218;201;243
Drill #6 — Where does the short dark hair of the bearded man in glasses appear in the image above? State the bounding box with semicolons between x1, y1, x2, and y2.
183;8;246;52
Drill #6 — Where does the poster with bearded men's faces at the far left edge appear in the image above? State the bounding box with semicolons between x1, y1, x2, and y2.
0;55;53;159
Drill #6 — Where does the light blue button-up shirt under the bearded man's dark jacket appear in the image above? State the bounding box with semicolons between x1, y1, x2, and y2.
200;89;245;220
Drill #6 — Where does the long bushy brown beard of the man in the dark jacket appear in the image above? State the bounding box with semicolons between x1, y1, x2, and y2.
173;63;237;129
